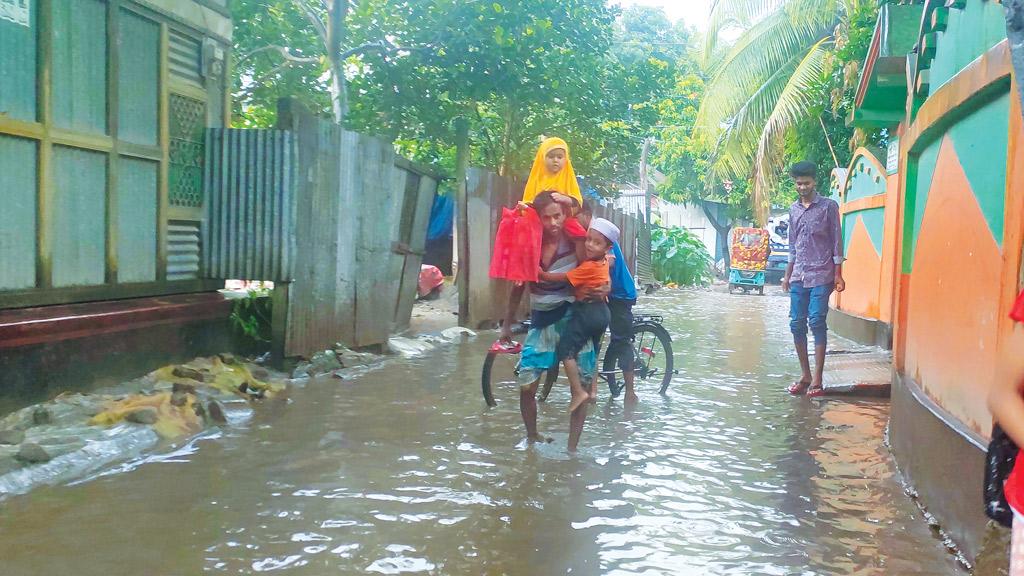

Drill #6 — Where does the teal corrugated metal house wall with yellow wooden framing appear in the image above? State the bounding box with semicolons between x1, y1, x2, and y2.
0;0;230;308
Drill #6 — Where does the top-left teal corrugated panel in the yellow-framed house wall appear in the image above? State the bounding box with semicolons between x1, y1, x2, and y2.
0;2;39;122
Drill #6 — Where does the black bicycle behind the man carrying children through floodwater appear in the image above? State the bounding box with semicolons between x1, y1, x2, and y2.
480;313;676;408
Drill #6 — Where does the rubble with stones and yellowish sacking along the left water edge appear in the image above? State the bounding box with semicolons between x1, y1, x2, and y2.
0;355;286;498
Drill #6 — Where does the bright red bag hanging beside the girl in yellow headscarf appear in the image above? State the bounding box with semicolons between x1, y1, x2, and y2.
490;204;544;282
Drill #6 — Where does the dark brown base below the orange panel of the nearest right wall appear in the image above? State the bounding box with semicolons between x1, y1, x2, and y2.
889;374;988;563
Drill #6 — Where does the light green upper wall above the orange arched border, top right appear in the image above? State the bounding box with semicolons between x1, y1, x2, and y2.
930;0;1007;94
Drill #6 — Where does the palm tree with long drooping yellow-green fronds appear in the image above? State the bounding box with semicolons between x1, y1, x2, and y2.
696;0;874;224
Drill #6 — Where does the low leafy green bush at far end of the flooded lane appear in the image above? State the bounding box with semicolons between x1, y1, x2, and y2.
650;227;713;286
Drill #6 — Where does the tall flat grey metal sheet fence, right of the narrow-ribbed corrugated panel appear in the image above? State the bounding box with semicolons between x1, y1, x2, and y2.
274;100;437;357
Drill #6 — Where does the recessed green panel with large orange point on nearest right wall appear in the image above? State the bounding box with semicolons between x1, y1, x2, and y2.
903;87;1010;433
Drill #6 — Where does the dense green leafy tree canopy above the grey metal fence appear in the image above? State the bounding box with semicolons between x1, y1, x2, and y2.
233;0;704;194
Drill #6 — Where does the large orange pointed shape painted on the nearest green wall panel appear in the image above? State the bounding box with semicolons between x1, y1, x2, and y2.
904;137;1002;430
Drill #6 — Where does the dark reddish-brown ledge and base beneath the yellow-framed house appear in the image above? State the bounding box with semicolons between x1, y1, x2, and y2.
0;292;234;414
